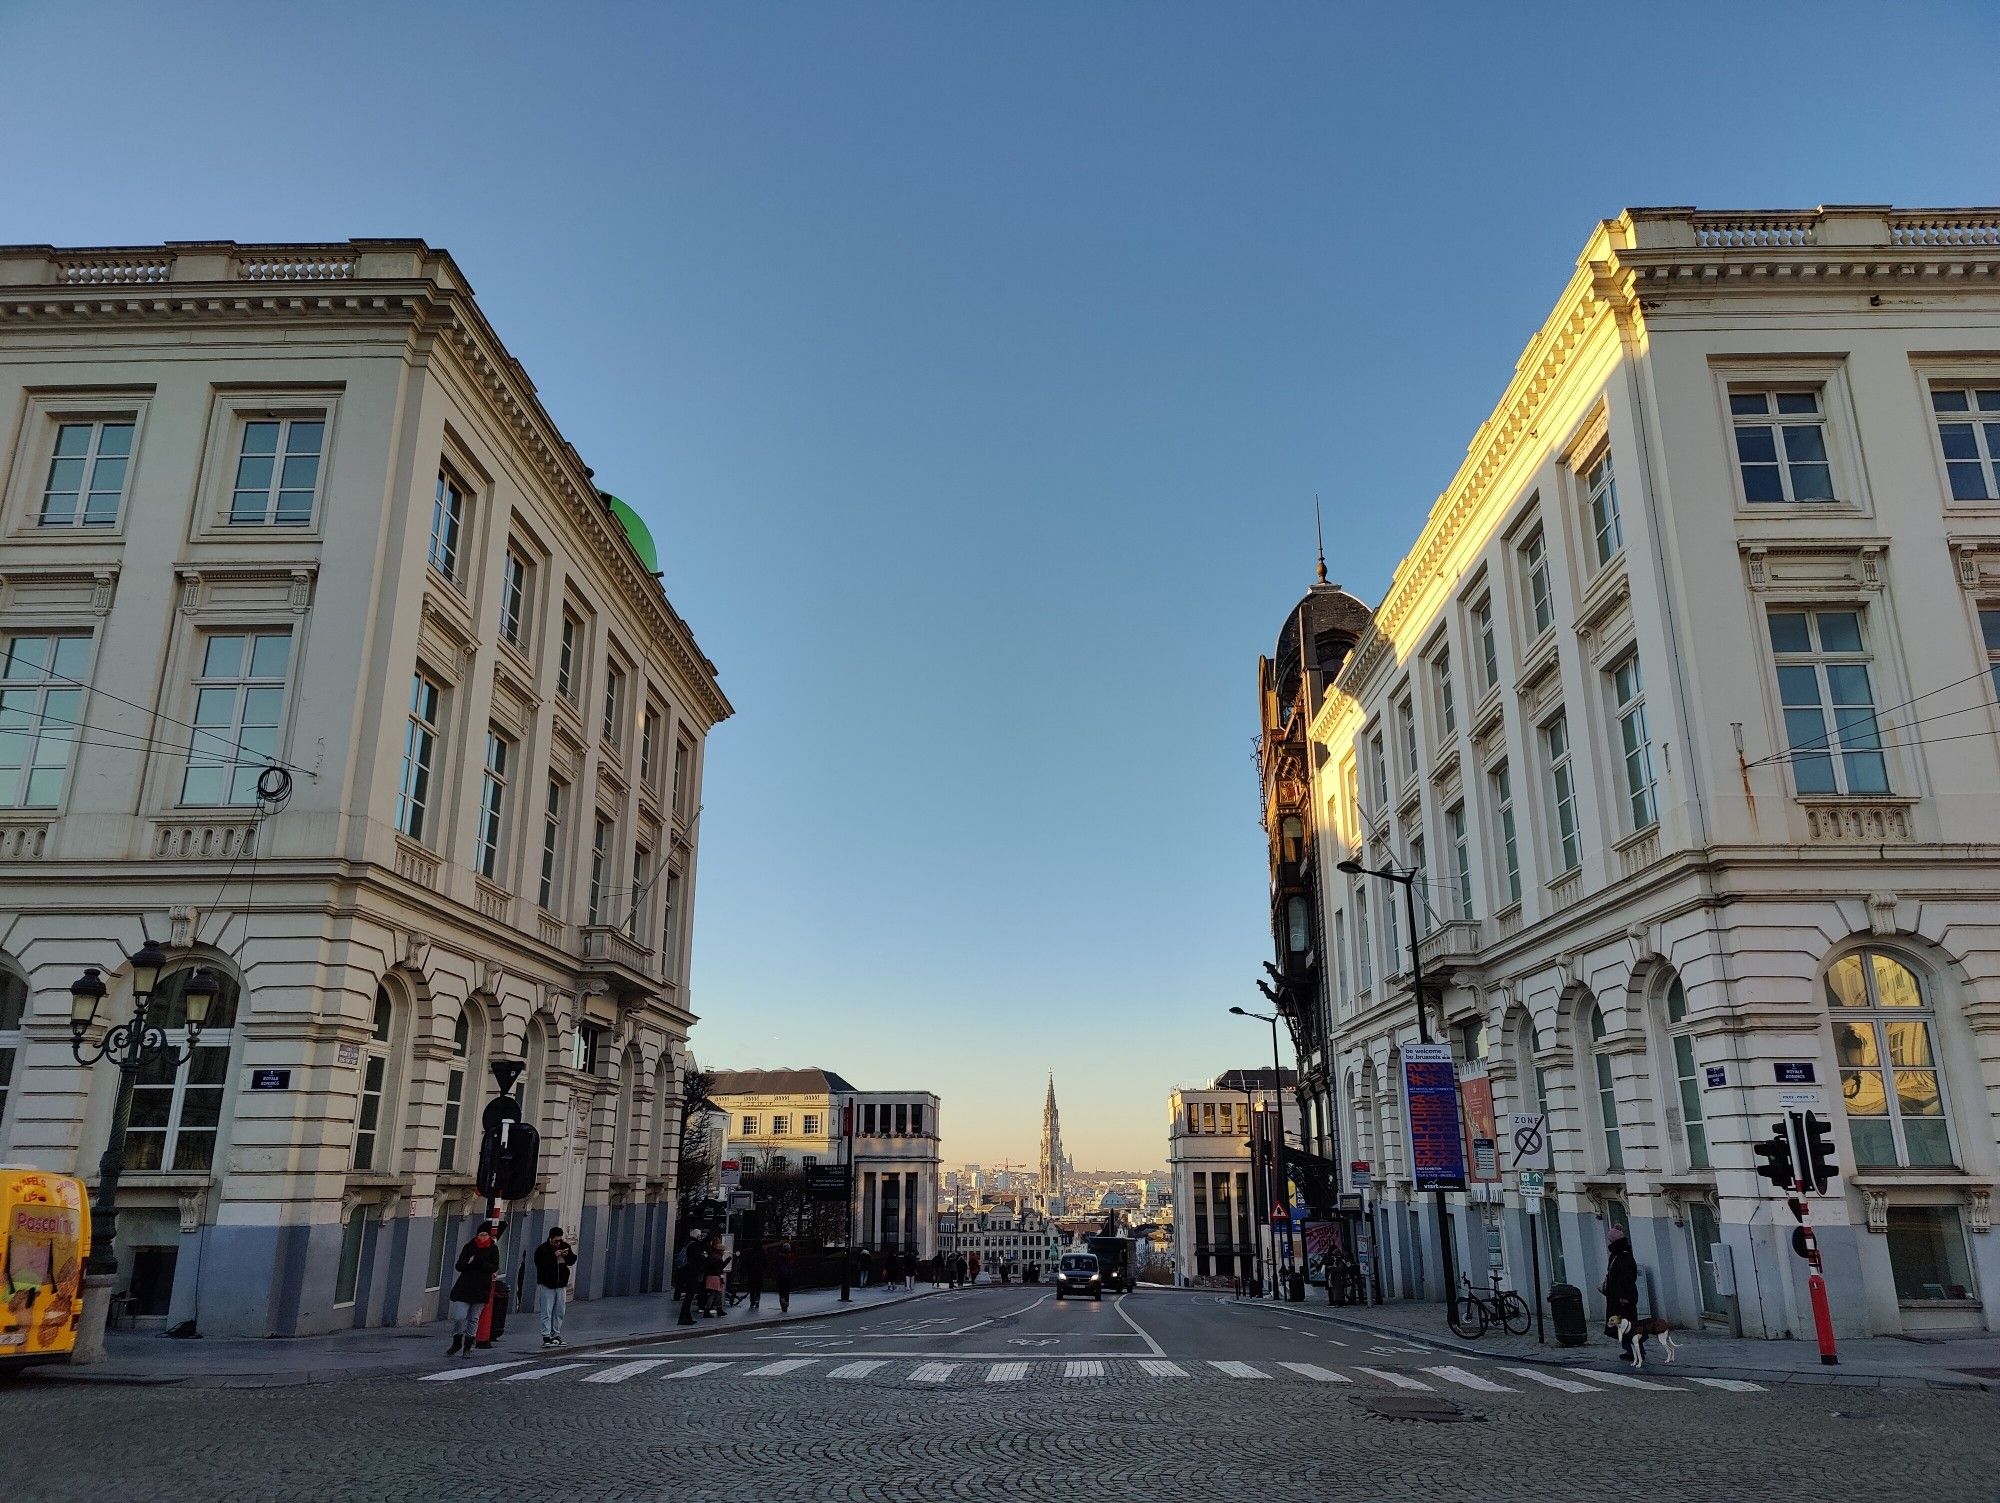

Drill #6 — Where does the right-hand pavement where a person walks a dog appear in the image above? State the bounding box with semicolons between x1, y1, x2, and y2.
1236;1299;2000;1393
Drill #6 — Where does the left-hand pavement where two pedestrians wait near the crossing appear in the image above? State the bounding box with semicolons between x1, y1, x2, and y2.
16;1283;934;1389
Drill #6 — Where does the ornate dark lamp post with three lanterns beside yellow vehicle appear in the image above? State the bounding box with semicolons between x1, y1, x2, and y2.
70;939;218;1361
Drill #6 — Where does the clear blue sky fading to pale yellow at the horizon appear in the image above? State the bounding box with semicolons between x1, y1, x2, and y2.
0;0;2000;1167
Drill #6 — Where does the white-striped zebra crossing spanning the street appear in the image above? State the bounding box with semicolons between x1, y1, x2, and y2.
418;1357;1764;1397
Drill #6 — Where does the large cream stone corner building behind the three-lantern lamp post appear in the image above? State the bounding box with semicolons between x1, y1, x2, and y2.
0;240;730;1335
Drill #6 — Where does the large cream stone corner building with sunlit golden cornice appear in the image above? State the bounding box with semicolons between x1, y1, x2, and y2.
1312;208;2000;1335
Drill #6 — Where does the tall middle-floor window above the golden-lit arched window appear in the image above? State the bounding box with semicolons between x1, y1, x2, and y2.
1770;610;1888;793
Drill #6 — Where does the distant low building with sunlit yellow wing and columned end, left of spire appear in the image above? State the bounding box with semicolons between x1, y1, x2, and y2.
710;1065;938;1257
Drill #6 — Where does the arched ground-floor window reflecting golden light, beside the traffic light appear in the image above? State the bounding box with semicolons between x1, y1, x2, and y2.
1826;949;1954;1167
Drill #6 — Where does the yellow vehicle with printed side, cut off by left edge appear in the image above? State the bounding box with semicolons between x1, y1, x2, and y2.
0;1163;90;1373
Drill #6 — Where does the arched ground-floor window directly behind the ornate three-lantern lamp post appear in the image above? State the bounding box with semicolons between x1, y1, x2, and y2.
126;965;240;1173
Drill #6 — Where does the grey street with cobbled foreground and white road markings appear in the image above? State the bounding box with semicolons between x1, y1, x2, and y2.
0;1285;2000;1503
